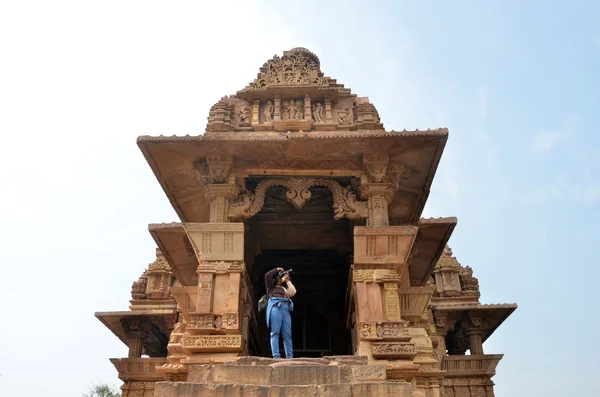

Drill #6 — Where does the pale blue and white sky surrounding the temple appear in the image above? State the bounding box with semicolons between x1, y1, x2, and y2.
0;0;600;397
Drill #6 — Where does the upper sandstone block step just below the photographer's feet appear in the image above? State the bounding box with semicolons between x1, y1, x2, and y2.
187;360;387;386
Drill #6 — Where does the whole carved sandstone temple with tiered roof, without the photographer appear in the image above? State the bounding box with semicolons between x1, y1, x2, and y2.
96;48;517;397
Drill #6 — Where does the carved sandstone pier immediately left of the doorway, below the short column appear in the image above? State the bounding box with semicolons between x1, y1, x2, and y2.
181;223;246;364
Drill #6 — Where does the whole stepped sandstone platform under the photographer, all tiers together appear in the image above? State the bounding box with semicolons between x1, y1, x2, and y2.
154;356;413;397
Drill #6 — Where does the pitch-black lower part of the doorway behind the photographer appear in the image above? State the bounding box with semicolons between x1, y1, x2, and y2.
252;249;351;357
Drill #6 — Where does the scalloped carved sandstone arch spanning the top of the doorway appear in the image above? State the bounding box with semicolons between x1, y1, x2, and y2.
229;178;369;220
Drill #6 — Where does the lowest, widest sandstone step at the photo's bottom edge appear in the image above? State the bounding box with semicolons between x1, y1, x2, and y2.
154;382;413;397
